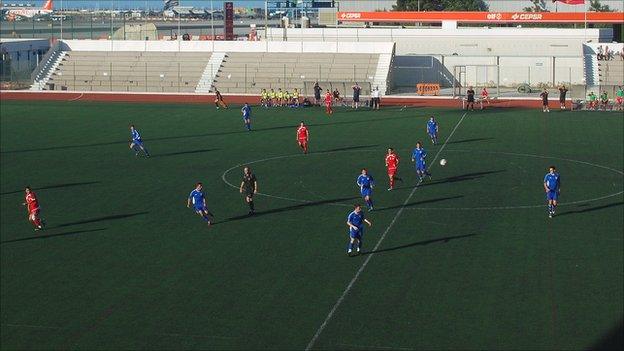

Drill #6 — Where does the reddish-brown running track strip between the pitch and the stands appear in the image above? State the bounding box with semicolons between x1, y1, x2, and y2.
0;90;569;108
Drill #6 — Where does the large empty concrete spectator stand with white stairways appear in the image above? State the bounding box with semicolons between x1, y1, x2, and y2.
31;40;394;95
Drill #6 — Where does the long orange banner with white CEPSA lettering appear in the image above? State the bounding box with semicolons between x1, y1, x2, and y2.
337;11;624;23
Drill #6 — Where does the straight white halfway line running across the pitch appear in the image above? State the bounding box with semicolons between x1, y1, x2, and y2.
305;112;468;350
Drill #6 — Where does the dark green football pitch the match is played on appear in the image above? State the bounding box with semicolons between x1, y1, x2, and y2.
0;101;624;350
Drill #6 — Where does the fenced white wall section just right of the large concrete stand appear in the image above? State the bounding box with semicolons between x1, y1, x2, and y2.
392;55;600;99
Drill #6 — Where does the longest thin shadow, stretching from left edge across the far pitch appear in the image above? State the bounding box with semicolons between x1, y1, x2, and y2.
0;116;420;154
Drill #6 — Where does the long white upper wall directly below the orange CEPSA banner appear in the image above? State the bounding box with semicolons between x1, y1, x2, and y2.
268;27;613;55
